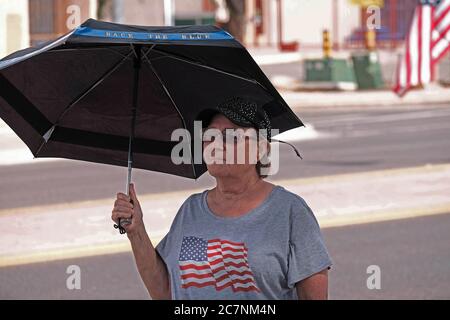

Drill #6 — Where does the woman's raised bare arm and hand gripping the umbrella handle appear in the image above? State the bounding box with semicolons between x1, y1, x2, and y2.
112;184;171;299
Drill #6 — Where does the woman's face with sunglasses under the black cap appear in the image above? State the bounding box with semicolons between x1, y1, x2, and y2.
203;114;259;177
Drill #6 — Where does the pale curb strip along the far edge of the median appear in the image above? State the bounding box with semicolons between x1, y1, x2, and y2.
0;164;450;216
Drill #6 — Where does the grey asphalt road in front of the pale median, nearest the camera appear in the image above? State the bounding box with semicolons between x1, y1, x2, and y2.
0;213;450;299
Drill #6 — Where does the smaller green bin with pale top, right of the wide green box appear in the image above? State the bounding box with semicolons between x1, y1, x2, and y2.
352;51;384;89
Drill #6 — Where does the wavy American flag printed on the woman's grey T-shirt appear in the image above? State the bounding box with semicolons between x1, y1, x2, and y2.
179;236;260;292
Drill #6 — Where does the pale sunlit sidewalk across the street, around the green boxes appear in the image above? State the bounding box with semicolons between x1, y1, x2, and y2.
248;47;450;109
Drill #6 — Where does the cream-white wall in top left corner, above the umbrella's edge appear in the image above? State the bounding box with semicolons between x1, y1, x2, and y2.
0;0;30;58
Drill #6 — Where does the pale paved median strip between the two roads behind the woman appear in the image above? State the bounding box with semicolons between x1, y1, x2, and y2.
0;164;450;267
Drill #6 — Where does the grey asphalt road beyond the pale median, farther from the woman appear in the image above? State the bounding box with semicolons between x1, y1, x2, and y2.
0;105;450;209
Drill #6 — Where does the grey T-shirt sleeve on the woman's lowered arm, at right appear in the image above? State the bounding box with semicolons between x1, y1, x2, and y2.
287;197;332;288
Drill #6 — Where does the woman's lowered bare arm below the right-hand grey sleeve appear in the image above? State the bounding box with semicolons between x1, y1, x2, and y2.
295;269;328;300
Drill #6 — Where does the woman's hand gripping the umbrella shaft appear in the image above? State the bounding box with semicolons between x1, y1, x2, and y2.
111;183;145;237
